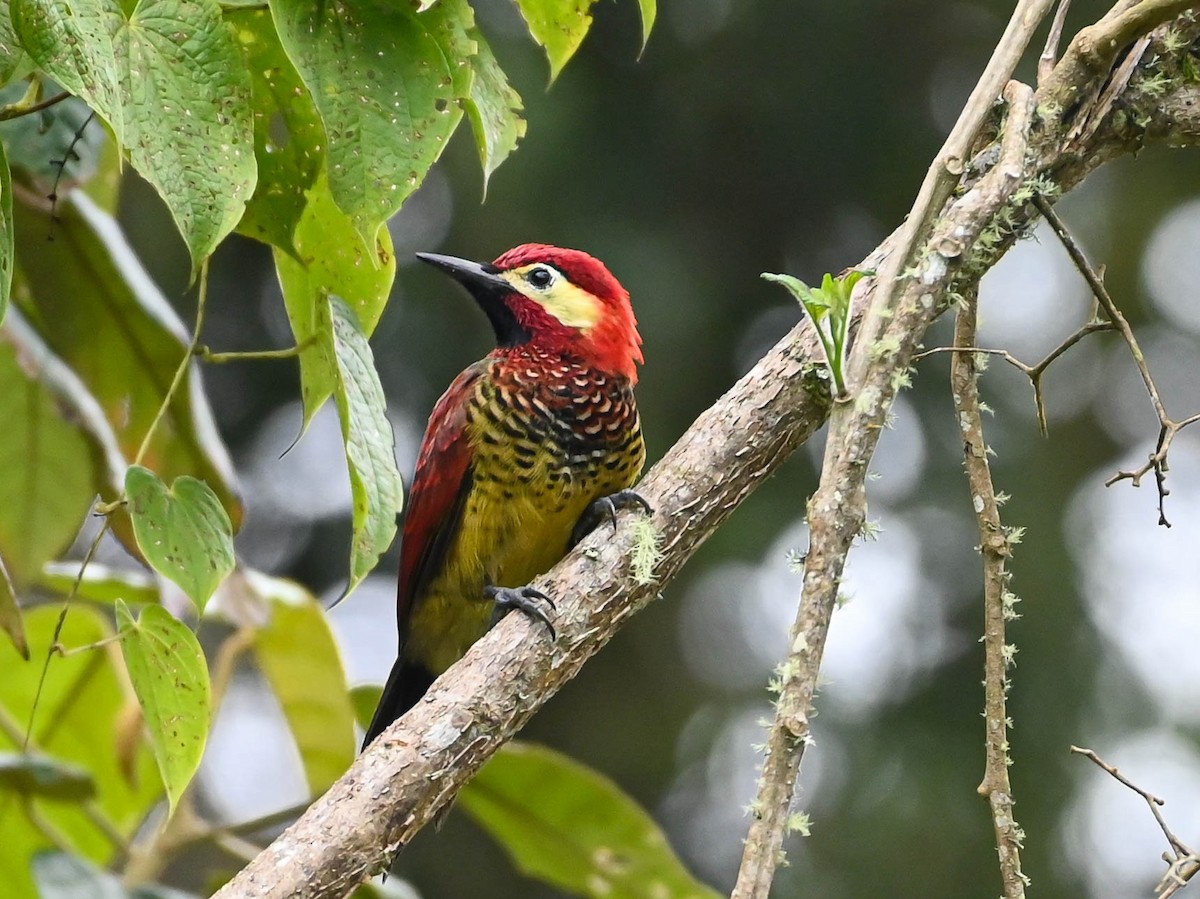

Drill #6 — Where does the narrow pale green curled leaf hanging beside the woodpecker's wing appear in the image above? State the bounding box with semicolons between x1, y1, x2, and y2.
324;294;404;593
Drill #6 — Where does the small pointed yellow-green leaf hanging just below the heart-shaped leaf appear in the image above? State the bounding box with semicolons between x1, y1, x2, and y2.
116;600;212;811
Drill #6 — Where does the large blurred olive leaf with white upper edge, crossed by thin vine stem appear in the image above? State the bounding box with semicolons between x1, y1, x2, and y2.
13;191;242;546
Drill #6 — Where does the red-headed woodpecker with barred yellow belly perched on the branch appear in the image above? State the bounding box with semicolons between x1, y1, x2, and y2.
364;244;649;748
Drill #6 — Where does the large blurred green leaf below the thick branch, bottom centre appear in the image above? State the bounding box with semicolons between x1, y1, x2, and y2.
458;743;719;899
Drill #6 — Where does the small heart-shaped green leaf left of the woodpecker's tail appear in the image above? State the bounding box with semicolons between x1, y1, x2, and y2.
125;466;234;612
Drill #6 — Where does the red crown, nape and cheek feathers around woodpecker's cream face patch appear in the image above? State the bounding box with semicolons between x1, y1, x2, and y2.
493;244;646;384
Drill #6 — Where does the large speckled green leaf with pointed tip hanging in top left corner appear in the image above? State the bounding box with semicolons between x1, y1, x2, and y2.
13;0;257;270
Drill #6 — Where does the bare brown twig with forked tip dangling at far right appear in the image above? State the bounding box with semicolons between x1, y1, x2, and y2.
1033;196;1200;527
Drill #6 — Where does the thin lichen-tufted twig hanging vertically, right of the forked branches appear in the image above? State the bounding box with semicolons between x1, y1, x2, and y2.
950;290;1027;899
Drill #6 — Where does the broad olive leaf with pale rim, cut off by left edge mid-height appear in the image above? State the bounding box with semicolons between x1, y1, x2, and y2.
0;308;125;589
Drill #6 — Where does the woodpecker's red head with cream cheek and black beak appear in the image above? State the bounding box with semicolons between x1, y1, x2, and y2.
416;244;643;383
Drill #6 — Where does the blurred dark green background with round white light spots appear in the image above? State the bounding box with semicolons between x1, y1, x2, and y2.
114;0;1200;899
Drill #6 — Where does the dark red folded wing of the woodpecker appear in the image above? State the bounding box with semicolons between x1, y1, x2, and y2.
396;362;486;628
